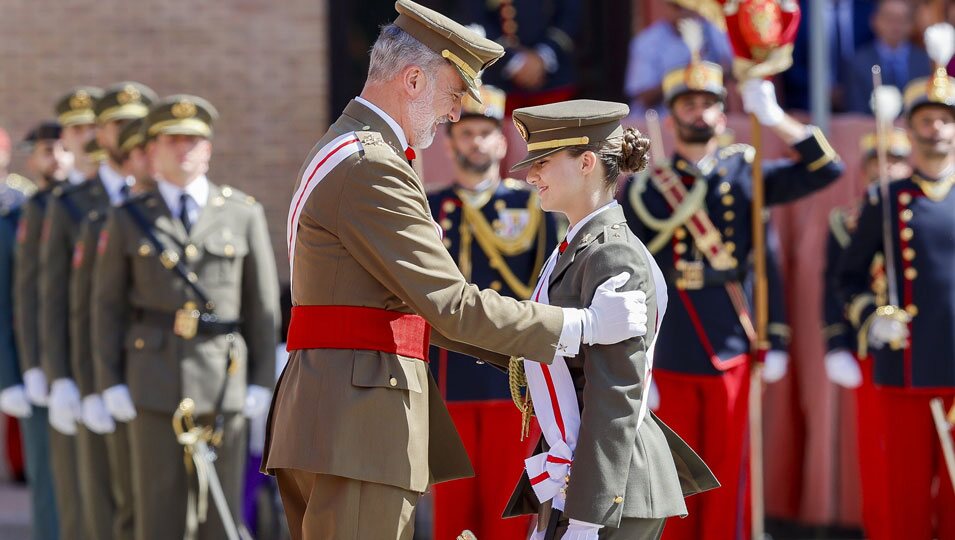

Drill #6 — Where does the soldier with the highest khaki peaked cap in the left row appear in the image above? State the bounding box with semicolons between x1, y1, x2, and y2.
69;81;157;539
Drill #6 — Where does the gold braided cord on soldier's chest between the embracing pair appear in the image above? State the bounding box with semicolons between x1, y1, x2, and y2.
459;193;546;300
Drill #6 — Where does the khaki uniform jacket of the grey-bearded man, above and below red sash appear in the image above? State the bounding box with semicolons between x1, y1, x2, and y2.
263;101;563;492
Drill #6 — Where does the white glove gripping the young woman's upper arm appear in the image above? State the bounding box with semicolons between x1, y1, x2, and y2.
582;272;647;345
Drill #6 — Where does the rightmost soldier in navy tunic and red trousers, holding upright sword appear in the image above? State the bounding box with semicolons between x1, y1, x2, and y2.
838;68;955;538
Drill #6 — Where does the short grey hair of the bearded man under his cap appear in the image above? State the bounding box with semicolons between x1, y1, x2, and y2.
368;24;445;83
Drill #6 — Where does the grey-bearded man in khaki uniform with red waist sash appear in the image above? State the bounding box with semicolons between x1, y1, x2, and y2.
263;0;646;539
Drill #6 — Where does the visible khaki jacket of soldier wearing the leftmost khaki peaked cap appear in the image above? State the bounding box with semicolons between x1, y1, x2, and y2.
40;176;109;382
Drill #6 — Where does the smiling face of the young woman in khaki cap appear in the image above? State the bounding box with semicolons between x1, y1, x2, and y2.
527;150;596;216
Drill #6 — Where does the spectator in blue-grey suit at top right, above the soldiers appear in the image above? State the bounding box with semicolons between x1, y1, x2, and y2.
843;0;932;114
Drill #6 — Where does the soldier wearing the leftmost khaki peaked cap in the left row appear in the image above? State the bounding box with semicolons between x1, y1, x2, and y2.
35;87;106;538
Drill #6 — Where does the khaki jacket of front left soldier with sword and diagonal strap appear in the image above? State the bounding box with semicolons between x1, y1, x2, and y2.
92;184;279;415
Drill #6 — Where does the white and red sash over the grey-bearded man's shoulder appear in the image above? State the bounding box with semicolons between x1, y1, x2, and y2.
286;131;444;281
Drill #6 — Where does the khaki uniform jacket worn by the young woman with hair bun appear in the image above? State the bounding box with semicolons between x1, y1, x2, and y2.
504;206;719;527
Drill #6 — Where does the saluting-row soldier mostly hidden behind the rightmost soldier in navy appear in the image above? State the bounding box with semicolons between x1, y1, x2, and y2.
822;128;912;537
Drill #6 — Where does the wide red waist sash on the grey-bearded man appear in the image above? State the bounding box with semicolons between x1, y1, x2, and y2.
287;306;431;361
